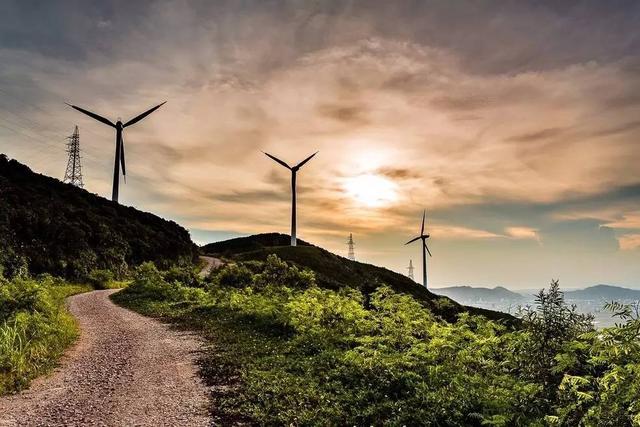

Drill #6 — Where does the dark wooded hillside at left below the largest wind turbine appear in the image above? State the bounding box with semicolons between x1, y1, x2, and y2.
0;155;197;278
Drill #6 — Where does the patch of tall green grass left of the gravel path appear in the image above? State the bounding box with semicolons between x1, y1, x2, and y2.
0;275;90;395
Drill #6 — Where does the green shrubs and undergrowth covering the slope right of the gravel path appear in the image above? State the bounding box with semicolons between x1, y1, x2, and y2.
114;256;640;426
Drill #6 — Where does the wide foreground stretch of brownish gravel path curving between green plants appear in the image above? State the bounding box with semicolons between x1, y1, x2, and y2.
0;291;209;427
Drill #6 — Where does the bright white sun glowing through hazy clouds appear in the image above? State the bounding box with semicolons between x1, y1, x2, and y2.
344;174;398;207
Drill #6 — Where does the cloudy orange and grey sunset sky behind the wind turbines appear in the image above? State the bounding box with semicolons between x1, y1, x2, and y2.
0;0;640;289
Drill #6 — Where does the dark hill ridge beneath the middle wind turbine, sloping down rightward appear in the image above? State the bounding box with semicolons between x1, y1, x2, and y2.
201;233;514;321
